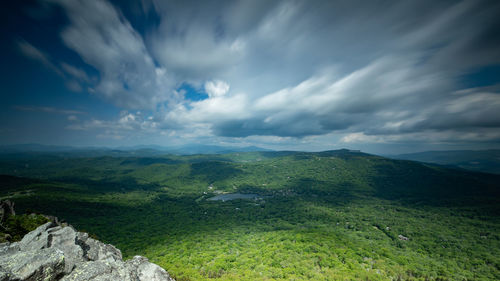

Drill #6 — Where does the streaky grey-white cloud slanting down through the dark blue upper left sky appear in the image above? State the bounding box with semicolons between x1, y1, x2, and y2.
47;0;174;109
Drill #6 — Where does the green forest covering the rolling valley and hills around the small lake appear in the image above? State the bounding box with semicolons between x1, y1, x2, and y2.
0;150;500;281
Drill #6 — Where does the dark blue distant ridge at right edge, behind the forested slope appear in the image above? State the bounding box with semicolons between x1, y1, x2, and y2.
386;149;500;174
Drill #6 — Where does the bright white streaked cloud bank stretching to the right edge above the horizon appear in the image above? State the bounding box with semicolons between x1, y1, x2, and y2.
153;52;500;143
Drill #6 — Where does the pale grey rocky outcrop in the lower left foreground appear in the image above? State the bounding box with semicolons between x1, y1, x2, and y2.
0;221;174;281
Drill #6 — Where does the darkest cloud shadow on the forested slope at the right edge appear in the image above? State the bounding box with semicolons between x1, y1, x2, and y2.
369;161;500;206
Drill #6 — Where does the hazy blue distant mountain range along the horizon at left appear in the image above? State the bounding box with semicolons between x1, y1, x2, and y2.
0;144;273;157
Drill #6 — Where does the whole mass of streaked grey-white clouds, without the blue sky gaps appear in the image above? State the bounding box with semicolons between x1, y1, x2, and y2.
30;0;500;142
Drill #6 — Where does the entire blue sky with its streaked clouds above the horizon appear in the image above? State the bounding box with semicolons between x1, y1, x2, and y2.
0;0;500;154
